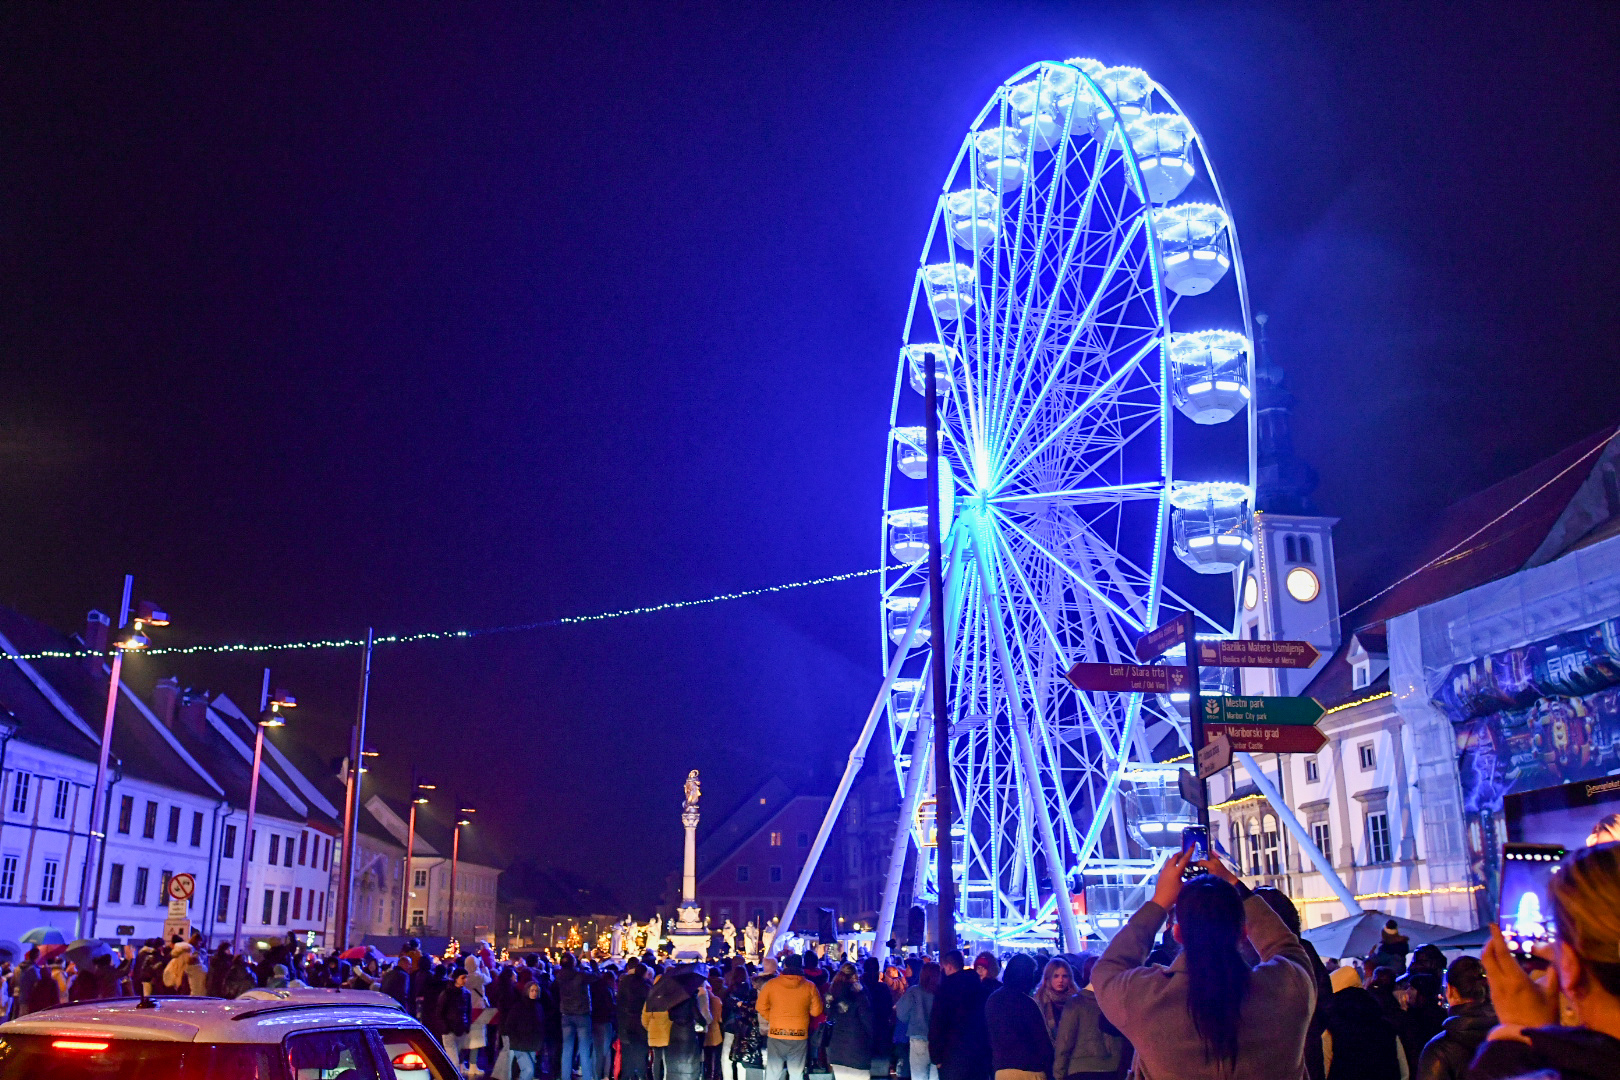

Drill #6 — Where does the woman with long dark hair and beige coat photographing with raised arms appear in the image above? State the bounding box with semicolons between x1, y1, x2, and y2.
1092;850;1317;1080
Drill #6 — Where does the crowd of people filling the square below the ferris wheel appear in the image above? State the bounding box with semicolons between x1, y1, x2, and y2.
0;844;1620;1080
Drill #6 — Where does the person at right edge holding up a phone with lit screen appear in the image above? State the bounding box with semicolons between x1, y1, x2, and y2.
1468;844;1620;1080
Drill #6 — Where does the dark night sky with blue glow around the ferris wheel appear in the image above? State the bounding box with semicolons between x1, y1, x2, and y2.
0;2;1620;908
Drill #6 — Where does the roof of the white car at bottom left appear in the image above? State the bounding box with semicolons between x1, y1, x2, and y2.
0;988;421;1043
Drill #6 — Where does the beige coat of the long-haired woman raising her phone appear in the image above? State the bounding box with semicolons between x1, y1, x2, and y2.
1092;895;1315;1080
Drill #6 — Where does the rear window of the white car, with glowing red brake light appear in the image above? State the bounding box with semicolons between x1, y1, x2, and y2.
0;1035;285;1080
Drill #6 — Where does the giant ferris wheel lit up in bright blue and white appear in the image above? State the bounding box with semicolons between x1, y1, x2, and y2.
878;58;1254;949
